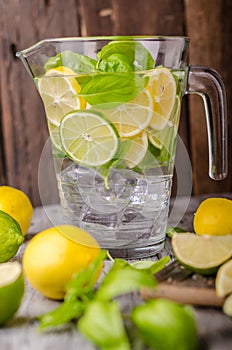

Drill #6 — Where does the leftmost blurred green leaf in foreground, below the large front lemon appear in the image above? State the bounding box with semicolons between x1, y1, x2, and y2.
39;300;84;331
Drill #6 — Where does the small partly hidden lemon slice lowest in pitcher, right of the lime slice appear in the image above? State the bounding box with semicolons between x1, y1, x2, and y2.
125;131;148;168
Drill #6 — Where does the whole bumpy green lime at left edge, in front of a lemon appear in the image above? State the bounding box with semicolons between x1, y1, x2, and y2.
0;210;24;263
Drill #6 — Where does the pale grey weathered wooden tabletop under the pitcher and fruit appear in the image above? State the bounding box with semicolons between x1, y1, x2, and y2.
0;194;232;350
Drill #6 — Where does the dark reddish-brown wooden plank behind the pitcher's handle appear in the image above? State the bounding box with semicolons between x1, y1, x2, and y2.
185;0;232;194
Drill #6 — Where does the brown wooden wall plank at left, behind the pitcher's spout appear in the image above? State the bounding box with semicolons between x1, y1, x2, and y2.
0;0;79;205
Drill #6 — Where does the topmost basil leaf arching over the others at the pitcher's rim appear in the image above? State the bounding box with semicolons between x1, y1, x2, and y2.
97;41;154;71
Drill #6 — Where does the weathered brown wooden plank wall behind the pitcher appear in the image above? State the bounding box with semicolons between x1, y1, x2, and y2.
0;0;232;205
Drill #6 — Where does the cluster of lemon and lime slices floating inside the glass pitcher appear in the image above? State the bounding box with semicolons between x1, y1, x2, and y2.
38;66;180;168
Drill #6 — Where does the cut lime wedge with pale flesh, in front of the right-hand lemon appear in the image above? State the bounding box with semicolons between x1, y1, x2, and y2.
172;233;232;275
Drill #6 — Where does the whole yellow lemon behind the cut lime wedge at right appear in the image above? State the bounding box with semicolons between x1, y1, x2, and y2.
193;198;232;235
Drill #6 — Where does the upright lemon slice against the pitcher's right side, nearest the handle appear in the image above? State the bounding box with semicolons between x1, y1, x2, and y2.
147;68;176;130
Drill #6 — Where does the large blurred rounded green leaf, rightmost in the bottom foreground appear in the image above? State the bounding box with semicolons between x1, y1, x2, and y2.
131;299;198;350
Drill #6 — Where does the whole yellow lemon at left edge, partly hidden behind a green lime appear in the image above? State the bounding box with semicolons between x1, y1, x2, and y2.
0;186;33;235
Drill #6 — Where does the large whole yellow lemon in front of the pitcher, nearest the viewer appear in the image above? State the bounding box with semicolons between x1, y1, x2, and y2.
22;225;100;300
